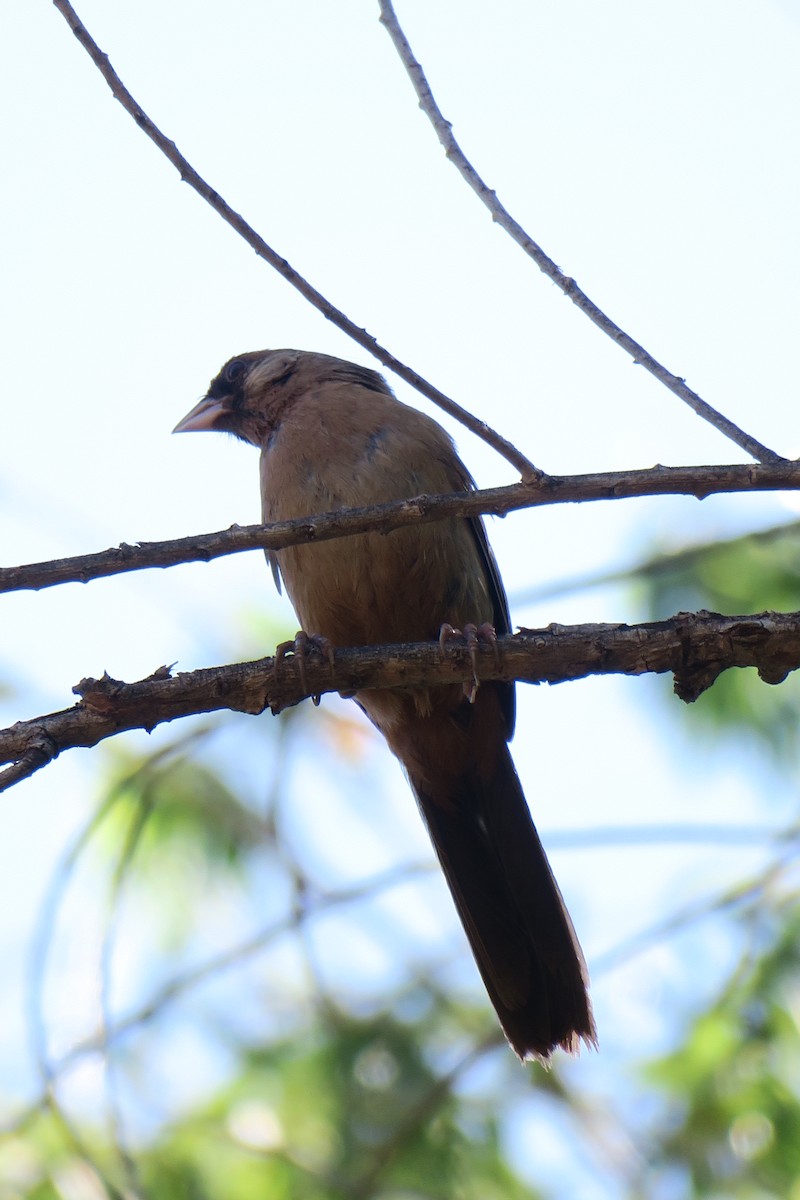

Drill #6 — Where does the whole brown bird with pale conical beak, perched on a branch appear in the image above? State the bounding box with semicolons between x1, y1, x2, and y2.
175;350;595;1060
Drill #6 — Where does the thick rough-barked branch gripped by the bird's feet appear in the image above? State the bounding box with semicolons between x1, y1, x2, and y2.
0;612;800;790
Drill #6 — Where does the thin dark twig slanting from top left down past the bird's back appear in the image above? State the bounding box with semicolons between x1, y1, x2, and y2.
53;0;542;480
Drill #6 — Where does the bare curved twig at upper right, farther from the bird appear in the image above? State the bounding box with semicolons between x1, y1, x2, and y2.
378;0;782;462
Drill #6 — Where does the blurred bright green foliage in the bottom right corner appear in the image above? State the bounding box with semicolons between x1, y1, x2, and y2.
646;893;800;1200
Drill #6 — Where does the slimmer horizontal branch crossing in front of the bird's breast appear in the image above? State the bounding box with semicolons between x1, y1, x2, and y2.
0;462;800;593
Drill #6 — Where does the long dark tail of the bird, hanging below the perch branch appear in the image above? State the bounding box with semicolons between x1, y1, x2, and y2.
383;688;595;1061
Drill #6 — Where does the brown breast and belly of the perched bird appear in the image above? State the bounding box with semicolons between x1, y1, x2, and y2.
261;401;494;646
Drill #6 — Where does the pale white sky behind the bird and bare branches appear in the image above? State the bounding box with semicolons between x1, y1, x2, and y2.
0;0;800;1196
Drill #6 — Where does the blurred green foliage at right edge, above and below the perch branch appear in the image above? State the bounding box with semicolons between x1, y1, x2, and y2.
642;521;800;764
